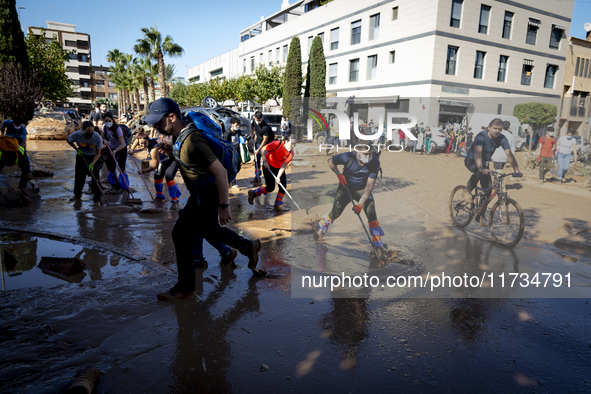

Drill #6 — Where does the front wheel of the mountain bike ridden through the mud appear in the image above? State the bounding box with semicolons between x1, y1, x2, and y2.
488;198;525;247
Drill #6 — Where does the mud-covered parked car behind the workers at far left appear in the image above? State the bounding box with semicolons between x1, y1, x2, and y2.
27;112;77;140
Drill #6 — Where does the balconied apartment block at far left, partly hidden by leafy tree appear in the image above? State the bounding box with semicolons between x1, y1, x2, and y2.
29;21;92;112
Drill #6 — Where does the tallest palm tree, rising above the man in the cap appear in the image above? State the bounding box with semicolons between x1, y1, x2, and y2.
133;27;185;97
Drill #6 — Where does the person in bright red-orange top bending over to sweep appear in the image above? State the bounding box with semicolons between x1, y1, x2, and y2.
248;135;295;213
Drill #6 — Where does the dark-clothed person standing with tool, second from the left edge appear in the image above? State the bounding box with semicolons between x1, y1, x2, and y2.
67;121;103;206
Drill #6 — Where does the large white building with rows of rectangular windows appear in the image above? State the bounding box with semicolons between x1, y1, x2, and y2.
186;0;573;125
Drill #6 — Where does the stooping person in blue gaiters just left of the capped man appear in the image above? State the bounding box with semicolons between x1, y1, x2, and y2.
129;133;181;210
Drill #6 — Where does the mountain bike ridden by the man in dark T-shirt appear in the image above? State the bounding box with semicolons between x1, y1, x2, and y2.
449;171;525;246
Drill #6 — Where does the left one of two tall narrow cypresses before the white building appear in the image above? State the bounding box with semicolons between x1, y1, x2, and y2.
283;36;302;140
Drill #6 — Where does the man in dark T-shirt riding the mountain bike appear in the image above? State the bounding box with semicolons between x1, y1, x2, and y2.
464;118;523;227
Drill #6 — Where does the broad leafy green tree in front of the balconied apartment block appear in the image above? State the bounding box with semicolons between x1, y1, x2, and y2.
25;31;76;102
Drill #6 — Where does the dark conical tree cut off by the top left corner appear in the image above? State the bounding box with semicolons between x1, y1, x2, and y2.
0;0;29;72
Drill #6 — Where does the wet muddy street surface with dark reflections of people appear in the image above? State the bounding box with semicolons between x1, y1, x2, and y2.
0;141;591;393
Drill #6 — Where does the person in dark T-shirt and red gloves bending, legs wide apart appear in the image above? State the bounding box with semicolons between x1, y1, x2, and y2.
314;146;387;261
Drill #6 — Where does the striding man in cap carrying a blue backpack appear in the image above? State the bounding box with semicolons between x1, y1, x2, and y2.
145;98;265;301
